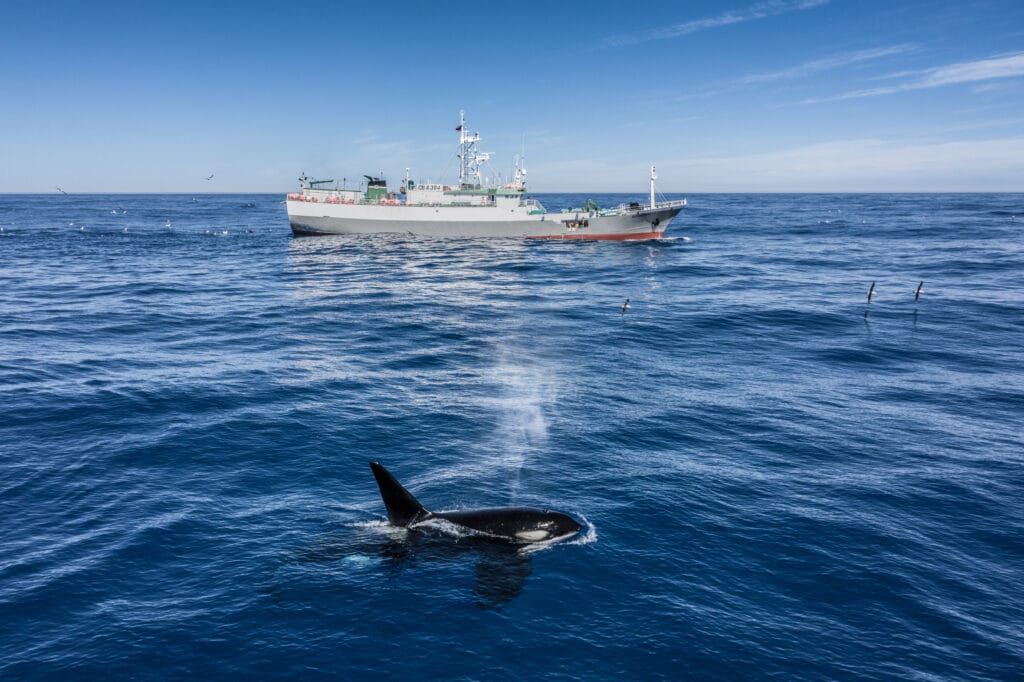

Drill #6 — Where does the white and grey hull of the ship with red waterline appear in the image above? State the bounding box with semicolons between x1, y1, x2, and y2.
287;199;686;240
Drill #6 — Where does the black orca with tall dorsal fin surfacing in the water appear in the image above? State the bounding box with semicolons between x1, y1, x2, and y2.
370;462;583;544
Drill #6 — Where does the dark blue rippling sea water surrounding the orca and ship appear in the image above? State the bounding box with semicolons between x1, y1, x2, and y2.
0;195;1024;680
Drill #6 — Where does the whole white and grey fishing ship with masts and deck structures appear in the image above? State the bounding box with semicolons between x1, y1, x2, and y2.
286;112;686;240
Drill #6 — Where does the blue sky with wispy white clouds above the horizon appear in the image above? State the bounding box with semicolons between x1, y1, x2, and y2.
0;0;1024;193
